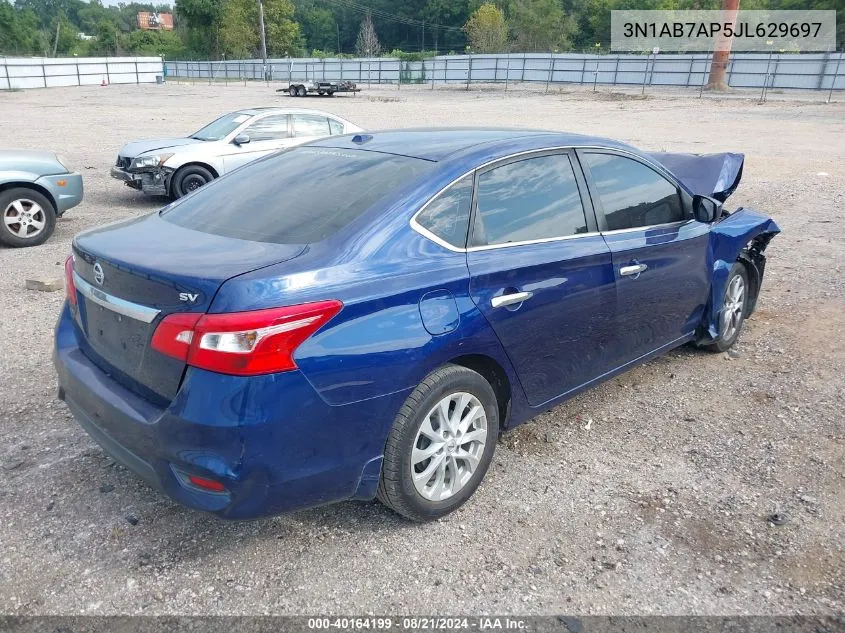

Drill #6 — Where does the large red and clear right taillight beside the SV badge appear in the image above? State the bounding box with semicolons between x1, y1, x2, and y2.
151;301;343;376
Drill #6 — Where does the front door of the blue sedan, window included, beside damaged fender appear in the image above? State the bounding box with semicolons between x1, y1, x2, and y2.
578;150;710;364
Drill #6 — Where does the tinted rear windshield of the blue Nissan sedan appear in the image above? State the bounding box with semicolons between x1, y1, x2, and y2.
161;147;433;244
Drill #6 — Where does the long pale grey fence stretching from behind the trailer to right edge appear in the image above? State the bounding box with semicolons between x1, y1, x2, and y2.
166;52;845;90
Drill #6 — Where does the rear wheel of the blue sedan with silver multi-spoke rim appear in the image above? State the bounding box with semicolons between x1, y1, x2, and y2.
378;365;499;521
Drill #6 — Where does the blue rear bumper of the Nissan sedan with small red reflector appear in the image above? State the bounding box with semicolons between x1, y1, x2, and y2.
53;306;398;519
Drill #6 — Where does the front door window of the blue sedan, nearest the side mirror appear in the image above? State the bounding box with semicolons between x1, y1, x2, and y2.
586;153;685;231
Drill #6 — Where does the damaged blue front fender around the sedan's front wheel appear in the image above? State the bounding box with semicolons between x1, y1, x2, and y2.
698;208;780;343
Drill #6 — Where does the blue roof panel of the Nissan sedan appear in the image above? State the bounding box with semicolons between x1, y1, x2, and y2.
310;128;639;162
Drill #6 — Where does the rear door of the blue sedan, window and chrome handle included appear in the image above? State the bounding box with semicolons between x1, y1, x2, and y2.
467;151;615;405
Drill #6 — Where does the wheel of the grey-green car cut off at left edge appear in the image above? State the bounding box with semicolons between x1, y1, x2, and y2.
0;187;56;248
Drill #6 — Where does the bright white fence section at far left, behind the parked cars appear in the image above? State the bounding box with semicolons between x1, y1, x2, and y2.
0;57;164;90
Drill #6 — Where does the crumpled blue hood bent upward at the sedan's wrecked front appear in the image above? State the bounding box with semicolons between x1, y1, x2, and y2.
649;152;745;202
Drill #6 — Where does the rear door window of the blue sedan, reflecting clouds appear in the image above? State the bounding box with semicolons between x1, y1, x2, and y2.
472;154;587;246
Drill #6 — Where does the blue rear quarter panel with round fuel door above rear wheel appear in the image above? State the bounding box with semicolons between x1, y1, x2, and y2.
212;229;516;405
